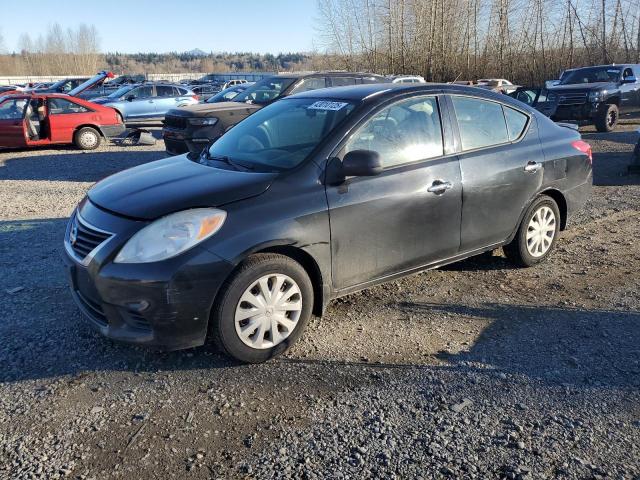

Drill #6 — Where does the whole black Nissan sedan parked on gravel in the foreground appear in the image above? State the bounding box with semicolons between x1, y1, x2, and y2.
64;84;592;362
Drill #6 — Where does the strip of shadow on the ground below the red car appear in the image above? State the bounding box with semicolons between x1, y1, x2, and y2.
0;146;166;182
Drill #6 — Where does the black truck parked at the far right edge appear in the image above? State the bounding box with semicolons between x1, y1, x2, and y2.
549;64;640;132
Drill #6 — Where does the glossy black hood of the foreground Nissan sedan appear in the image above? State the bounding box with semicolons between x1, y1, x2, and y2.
87;155;277;220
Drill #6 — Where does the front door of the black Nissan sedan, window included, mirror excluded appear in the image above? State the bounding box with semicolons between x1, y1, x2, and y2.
326;95;462;290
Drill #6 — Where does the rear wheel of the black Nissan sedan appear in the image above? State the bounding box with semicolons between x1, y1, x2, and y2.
503;195;561;267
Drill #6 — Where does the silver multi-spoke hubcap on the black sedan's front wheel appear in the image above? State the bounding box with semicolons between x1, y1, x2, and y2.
235;273;302;349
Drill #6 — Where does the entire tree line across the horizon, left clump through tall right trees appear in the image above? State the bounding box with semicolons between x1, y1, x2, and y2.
0;0;640;84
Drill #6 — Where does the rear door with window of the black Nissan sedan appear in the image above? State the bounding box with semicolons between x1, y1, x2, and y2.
449;95;544;252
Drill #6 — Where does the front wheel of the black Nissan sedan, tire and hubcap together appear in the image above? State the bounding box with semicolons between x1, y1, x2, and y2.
210;253;313;363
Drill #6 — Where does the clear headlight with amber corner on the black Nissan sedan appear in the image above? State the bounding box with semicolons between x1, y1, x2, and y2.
114;208;227;263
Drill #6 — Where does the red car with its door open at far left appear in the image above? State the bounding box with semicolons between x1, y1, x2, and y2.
0;93;125;150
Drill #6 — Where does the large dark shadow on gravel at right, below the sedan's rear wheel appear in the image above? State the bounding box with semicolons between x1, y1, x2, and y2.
398;302;640;389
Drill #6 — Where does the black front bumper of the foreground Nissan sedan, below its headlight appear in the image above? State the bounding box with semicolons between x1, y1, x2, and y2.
64;200;233;350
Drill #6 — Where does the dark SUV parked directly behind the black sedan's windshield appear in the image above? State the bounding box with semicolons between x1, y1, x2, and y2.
162;72;389;155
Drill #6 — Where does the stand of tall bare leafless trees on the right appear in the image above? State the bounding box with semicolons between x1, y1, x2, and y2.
318;0;640;84
